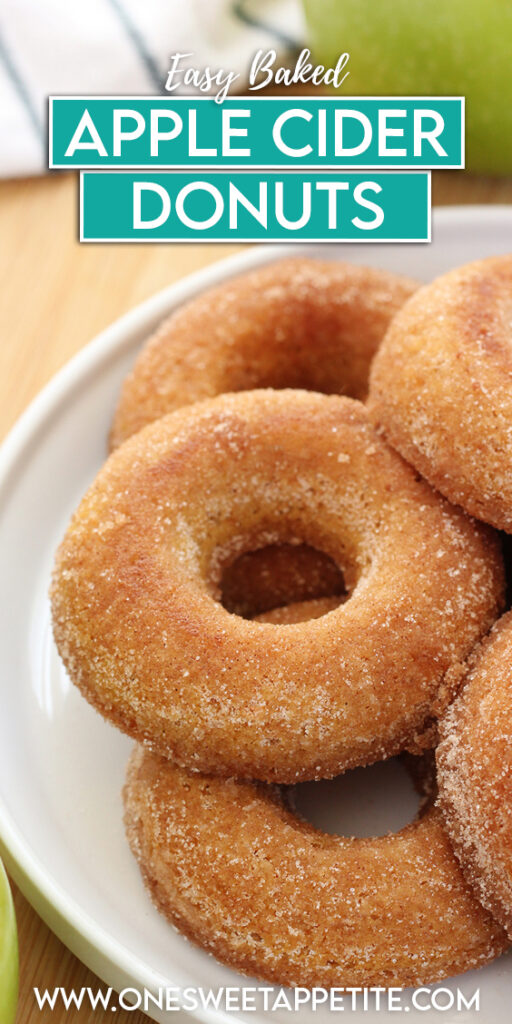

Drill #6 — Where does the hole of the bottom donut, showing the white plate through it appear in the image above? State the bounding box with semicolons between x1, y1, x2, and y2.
288;758;422;839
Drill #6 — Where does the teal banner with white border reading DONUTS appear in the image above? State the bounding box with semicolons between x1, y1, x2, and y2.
81;171;430;242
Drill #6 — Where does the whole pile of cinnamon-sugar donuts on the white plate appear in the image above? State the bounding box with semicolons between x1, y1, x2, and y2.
51;256;512;987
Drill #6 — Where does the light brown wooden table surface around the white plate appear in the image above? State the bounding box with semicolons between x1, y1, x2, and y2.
0;171;512;1024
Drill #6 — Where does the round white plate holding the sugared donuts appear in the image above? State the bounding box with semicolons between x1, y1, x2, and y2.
0;207;512;1024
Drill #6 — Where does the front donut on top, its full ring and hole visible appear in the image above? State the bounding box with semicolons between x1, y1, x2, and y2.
51;389;504;782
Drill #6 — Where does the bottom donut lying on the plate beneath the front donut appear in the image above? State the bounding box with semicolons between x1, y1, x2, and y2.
124;746;507;988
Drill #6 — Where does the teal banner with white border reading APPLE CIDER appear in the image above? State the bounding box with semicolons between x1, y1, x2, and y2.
49;96;464;169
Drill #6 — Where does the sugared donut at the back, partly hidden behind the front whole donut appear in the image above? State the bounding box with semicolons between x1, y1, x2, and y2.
111;259;418;447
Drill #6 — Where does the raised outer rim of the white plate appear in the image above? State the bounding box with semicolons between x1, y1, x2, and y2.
0;204;512;1024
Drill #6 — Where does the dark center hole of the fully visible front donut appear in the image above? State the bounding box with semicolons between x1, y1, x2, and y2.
219;543;348;622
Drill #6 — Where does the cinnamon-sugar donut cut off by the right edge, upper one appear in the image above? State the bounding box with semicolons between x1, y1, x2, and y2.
369;255;512;532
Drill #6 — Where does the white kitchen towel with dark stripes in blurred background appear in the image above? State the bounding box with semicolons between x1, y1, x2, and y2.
0;0;304;177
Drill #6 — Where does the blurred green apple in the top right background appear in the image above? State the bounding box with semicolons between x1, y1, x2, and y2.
303;0;512;174
